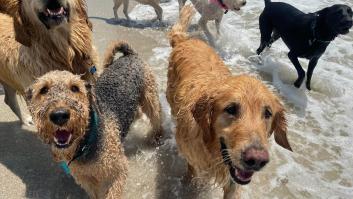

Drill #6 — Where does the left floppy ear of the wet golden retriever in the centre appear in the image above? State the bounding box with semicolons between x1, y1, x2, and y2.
191;95;214;144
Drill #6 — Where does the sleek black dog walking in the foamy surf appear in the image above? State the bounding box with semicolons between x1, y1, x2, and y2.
257;0;352;90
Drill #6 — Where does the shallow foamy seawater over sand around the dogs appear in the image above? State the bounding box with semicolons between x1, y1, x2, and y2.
88;0;353;199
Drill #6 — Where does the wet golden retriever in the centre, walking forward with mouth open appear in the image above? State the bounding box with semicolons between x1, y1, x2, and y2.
167;6;291;198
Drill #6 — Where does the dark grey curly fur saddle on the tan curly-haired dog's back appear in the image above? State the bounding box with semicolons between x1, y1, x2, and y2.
95;45;145;138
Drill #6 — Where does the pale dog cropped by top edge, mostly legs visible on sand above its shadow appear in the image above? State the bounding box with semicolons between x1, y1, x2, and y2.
113;0;163;21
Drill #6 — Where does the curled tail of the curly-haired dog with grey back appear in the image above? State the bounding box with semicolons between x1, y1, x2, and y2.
103;41;137;68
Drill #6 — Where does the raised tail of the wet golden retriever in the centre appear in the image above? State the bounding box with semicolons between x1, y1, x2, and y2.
168;5;195;47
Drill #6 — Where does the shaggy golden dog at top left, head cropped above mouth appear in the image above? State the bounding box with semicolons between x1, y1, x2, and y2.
0;0;100;124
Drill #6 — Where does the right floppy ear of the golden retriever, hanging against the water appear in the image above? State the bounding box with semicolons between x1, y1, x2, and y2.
271;105;293;151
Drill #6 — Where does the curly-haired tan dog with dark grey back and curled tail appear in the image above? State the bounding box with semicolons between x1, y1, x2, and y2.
26;42;162;199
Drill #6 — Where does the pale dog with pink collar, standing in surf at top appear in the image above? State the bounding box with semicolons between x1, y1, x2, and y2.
178;0;246;46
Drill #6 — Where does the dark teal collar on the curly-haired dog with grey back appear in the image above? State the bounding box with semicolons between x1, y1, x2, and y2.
67;108;99;166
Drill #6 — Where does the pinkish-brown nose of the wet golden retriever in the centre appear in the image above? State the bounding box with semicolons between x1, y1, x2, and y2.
242;147;269;171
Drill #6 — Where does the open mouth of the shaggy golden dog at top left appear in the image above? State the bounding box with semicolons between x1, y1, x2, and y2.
38;0;70;29
